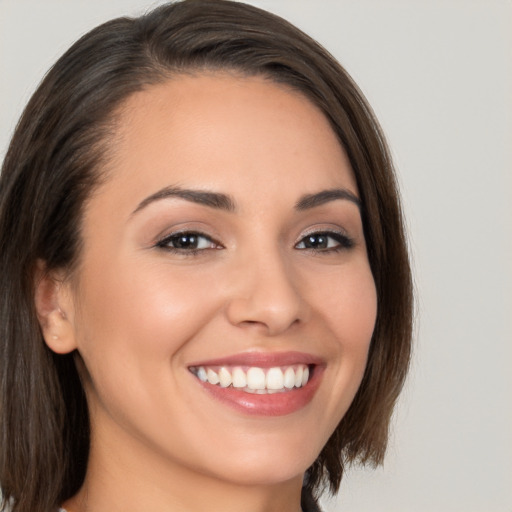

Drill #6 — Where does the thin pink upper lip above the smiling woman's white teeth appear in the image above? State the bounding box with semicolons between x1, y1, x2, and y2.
189;351;324;368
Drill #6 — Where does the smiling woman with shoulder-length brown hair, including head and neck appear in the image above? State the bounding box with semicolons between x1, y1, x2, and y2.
0;0;412;512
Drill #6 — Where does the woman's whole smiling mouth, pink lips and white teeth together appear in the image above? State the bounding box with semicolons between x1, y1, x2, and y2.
188;352;325;416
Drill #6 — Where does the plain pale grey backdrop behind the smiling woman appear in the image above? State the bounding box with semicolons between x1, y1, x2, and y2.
0;0;512;512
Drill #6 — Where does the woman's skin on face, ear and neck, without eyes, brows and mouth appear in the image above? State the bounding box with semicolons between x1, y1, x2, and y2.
36;73;376;512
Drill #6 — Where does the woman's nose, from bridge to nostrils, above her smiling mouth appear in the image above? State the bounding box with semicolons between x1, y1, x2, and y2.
227;251;308;336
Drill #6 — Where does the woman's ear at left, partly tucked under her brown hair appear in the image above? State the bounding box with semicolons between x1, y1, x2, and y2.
34;261;77;354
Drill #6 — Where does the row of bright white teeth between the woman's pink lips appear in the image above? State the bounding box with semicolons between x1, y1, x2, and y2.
190;364;309;393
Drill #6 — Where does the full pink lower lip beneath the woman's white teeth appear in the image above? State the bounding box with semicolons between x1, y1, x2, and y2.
196;365;323;416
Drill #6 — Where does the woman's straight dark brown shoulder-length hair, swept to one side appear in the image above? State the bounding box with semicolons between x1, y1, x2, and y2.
0;0;412;512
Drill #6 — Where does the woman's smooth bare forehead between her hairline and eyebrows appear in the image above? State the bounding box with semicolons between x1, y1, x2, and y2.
95;73;357;209
